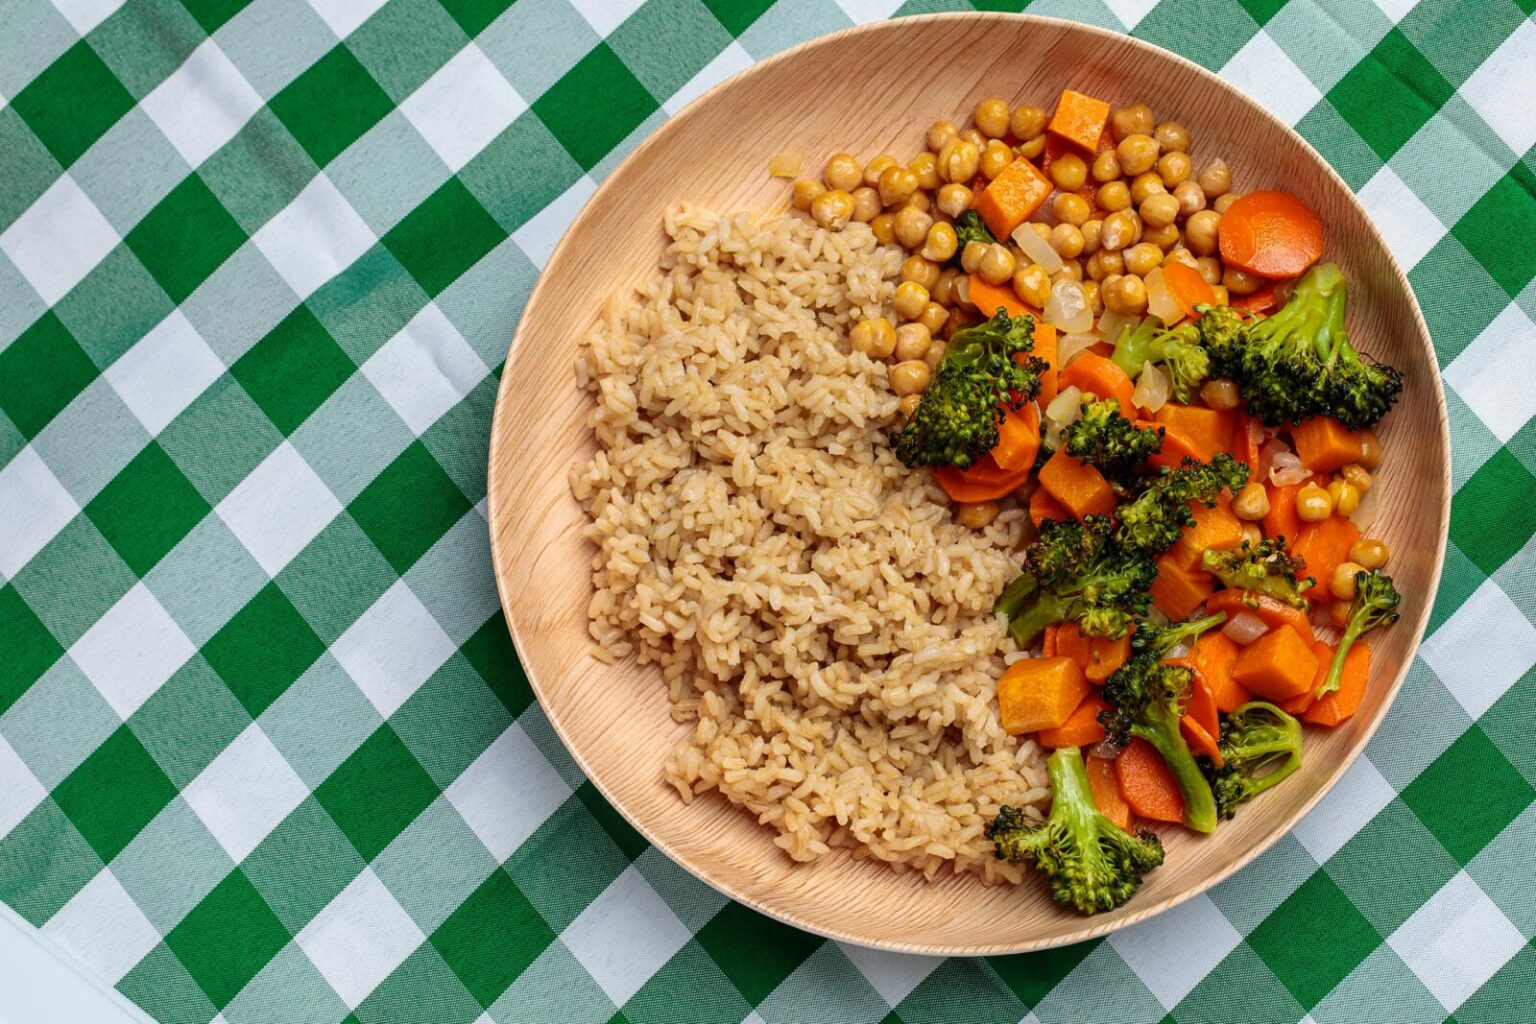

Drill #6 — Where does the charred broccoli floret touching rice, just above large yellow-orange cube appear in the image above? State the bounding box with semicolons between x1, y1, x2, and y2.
994;516;1157;648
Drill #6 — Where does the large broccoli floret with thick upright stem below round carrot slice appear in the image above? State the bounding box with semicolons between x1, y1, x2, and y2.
1197;263;1402;430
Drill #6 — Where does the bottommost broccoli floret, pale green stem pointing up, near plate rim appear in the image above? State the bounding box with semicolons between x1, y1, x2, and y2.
986;746;1163;913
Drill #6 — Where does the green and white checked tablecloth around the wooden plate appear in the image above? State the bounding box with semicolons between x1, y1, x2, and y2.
0;0;1536;1024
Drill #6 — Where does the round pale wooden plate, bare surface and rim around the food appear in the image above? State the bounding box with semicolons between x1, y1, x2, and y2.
490;14;1450;955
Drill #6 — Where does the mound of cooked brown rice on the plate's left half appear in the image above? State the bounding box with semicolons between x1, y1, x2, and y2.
570;206;1048;881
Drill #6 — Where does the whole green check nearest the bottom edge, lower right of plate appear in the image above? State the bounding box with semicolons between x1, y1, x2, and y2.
1247;870;1381;1007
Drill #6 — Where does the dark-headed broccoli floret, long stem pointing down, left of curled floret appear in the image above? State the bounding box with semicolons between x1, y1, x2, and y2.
1098;657;1217;832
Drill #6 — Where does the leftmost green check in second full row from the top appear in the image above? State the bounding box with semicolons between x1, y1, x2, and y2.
124;173;246;302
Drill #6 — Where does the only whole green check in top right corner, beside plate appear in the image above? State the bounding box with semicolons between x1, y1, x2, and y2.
1327;28;1456;160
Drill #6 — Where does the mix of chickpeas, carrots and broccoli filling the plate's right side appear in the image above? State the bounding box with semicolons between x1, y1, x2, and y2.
793;89;1402;913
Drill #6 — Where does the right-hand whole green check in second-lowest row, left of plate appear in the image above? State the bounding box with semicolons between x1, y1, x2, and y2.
315;723;439;860
